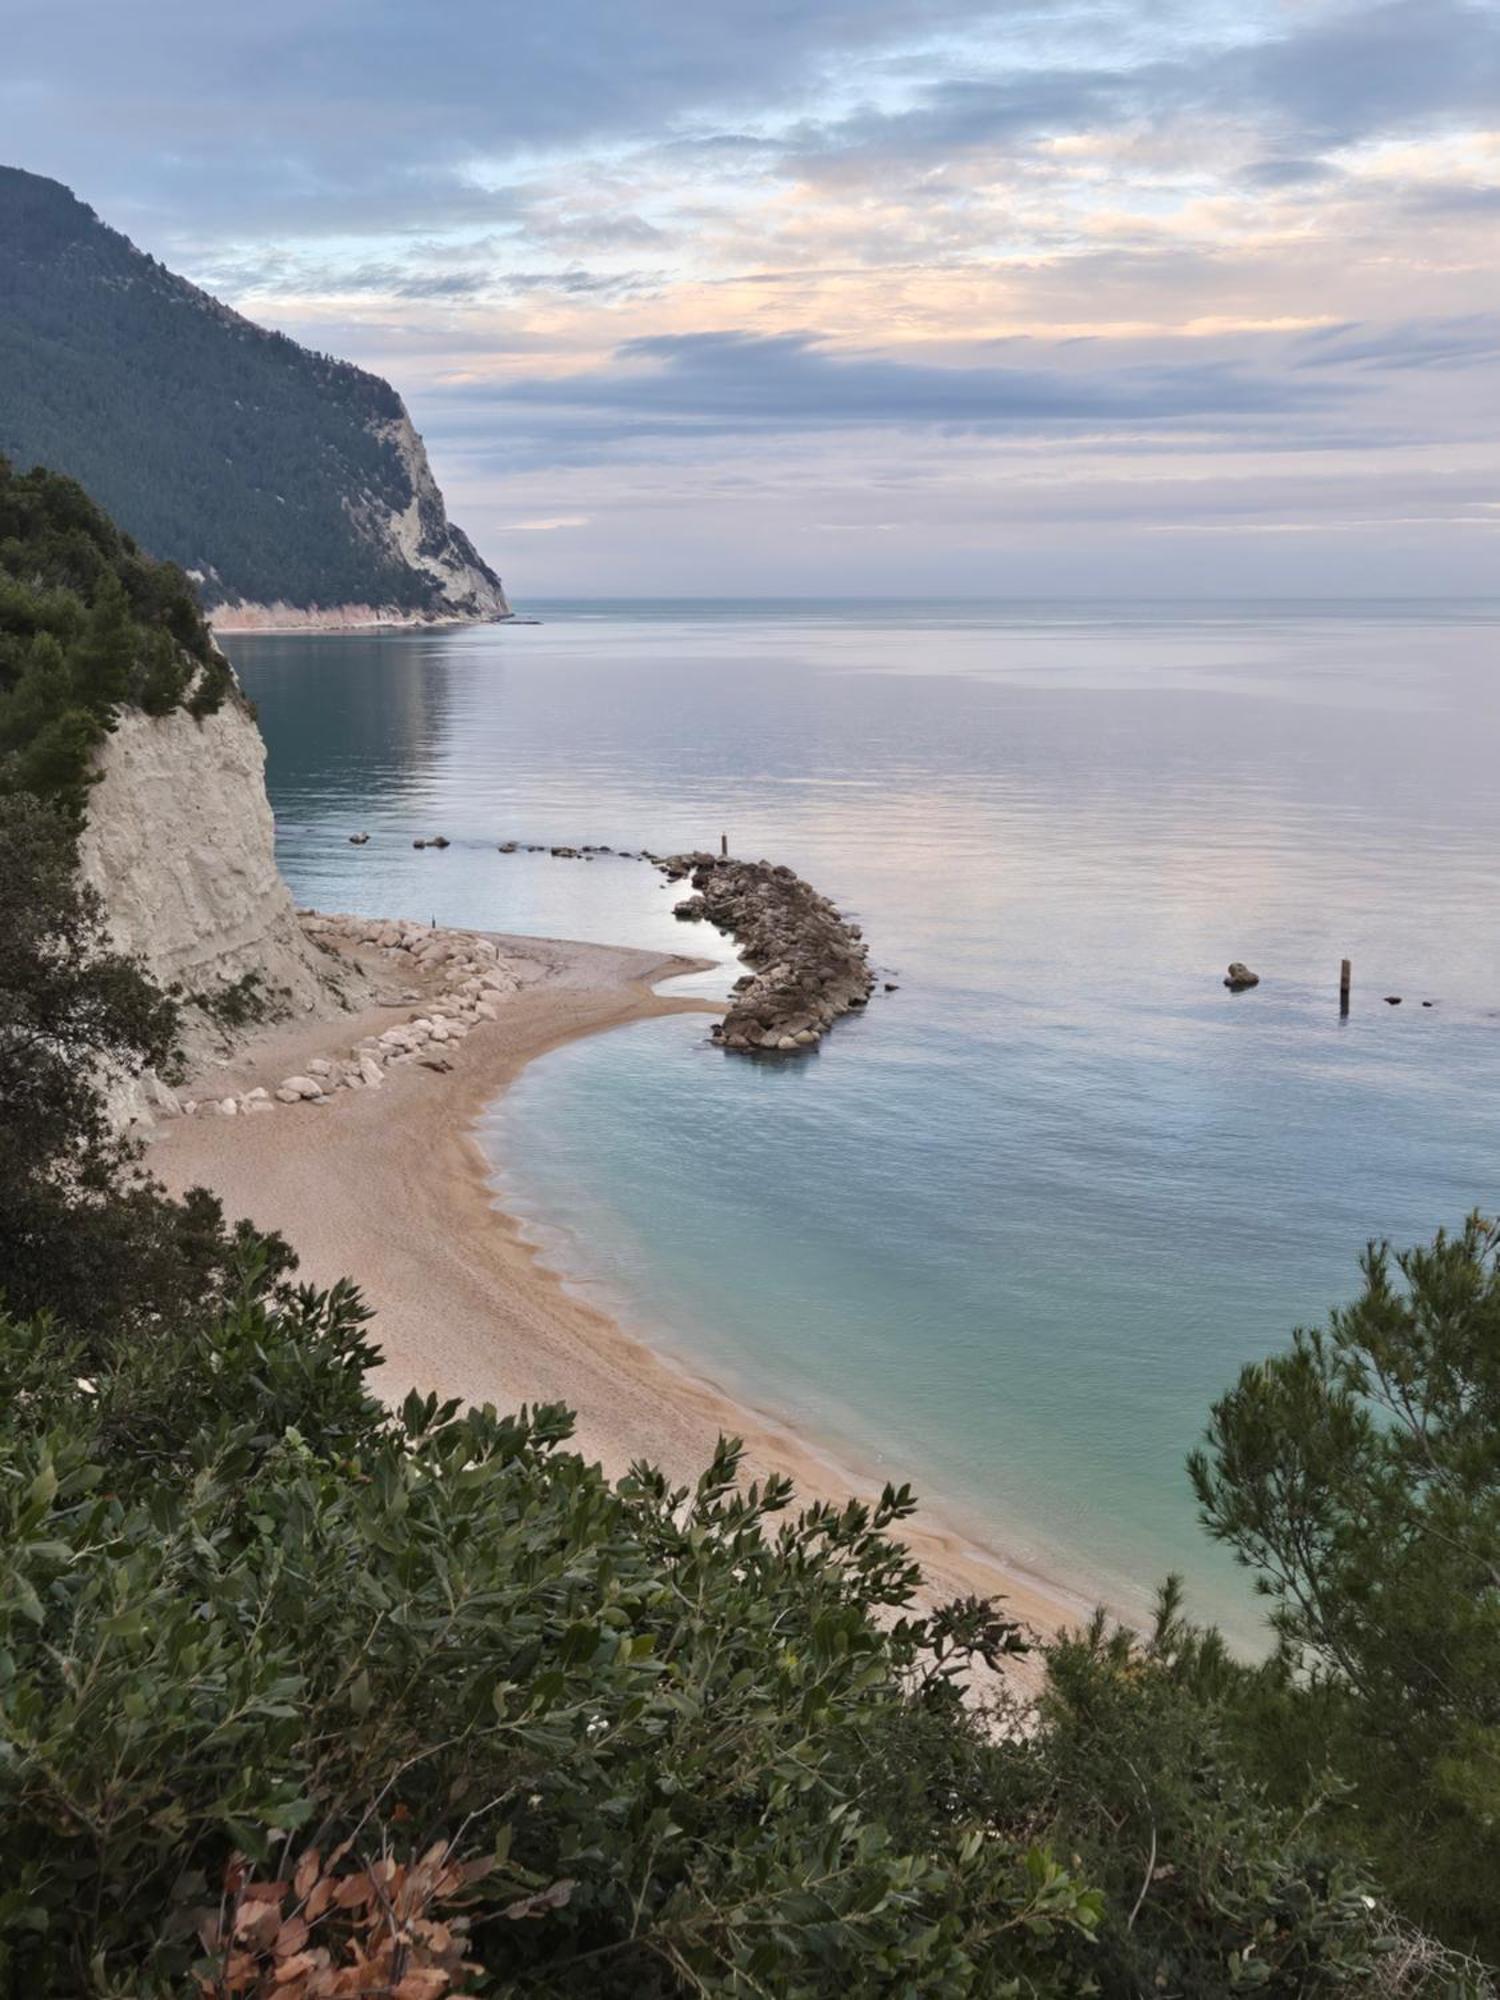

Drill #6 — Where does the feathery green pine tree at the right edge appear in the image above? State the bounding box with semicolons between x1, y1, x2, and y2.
1192;1218;1500;1962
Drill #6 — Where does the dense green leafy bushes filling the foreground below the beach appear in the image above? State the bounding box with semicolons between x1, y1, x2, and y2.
0;1258;1448;1996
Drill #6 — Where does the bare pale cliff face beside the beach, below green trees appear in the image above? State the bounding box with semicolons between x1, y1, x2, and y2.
78;700;360;1122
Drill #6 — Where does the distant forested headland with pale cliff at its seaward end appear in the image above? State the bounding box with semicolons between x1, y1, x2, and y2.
0;168;510;628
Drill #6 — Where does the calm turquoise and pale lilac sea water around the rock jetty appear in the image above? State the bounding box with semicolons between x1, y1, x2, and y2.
232;602;1500;1632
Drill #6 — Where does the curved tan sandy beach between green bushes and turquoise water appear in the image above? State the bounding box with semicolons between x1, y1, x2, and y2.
150;938;1090;1664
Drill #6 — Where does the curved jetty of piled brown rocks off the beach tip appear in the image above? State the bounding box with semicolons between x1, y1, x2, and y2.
656;854;874;1056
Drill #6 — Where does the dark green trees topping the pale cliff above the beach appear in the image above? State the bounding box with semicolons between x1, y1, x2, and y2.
0;458;234;824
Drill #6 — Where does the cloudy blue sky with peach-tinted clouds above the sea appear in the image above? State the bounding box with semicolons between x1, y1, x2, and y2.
0;0;1500;606
